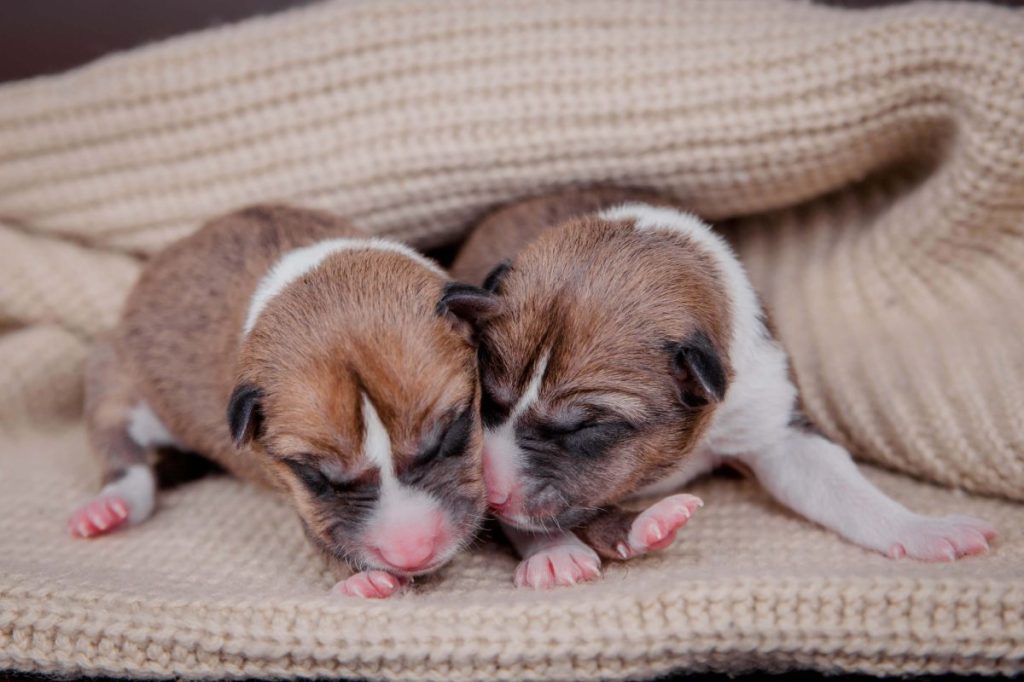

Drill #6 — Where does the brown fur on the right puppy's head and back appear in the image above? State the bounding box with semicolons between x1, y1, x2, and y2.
453;190;731;540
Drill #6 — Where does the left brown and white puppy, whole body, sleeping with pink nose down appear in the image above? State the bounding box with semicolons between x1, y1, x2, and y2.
71;206;488;597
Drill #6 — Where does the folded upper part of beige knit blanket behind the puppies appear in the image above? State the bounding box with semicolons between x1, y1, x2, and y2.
0;0;1024;500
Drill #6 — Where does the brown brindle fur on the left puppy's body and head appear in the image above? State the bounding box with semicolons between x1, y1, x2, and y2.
88;206;483;563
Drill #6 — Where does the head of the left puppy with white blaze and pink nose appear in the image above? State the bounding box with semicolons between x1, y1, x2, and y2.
227;244;490;574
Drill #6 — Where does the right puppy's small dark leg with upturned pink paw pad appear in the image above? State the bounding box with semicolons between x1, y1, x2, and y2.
578;494;703;560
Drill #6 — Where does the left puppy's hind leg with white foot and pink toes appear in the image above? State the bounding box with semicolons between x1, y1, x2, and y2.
68;341;158;538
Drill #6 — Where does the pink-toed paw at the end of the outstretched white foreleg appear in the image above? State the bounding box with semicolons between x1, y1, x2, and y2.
888;515;995;561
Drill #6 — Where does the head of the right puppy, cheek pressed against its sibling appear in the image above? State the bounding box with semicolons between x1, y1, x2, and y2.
468;209;731;529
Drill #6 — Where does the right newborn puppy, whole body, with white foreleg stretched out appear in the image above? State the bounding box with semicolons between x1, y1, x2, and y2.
453;190;994;587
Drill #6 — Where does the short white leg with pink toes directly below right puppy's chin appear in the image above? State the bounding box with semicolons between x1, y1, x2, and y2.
502;523;601;590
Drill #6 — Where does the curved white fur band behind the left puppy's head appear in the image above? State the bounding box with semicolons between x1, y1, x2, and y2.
242;238;447;336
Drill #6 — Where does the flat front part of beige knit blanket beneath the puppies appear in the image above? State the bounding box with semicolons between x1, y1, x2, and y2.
0;429;1024;680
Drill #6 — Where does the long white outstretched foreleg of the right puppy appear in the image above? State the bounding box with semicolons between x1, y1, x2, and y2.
739;428;995;561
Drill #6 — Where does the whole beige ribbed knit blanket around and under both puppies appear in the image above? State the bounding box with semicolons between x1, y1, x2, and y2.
0;0;1024;679
